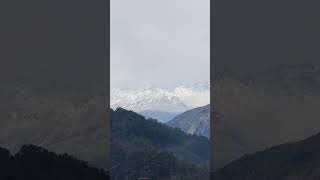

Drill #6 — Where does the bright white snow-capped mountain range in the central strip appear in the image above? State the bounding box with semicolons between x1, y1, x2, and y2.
110;82;210;121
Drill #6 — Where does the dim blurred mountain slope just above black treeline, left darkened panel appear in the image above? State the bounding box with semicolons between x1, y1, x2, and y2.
0;84;108;169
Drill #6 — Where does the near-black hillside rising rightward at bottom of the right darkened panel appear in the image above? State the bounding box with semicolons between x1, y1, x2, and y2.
214;134;320;180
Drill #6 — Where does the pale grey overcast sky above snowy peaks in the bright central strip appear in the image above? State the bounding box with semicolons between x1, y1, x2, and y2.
110;0;210;88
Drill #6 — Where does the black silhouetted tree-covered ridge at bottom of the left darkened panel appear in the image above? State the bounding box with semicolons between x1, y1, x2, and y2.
0;145;110;180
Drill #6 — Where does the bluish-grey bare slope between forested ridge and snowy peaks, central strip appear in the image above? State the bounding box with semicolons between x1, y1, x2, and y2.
167;105;210;138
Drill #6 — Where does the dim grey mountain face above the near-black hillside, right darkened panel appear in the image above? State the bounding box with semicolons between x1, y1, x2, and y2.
211;64;320;170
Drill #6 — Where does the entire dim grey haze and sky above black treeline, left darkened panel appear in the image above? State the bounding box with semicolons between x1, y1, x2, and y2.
0;0;109;169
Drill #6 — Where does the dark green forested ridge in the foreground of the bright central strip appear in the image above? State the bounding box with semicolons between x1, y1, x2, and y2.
110;108;210;180
